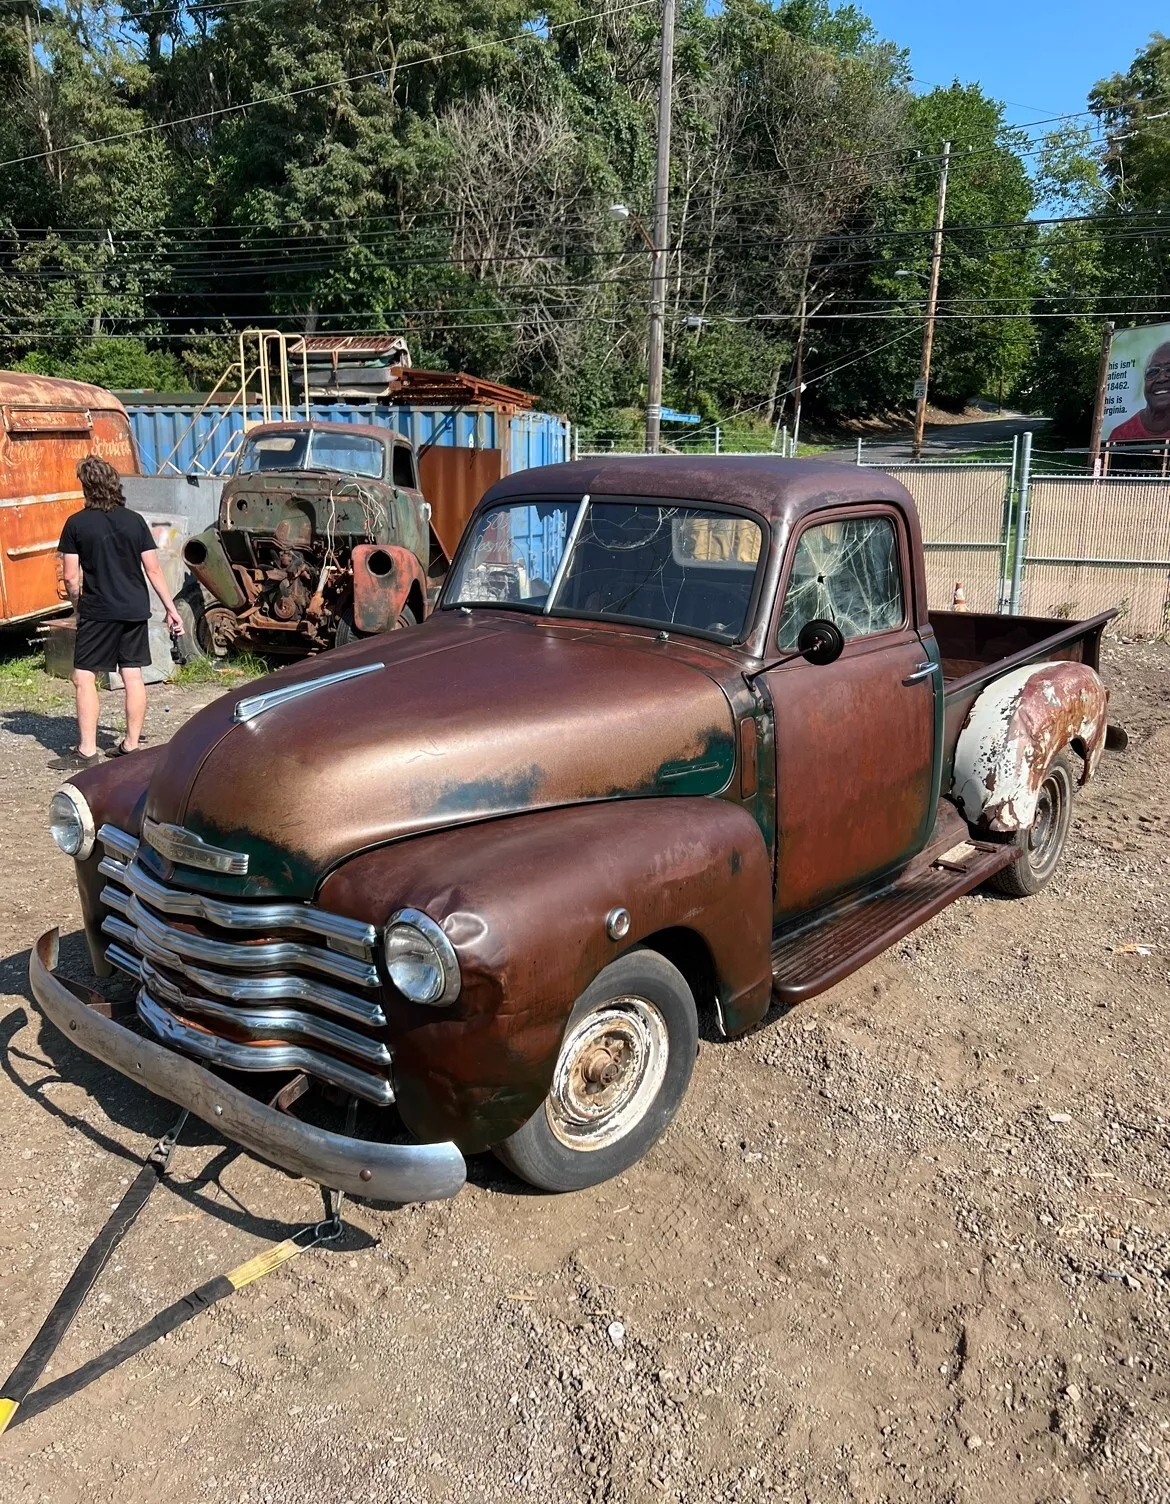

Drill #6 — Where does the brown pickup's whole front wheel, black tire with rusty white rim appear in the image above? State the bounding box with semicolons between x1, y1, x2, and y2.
492;951;699;1191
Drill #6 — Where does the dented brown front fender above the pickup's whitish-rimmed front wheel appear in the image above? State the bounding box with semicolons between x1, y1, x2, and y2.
317;797;771;1152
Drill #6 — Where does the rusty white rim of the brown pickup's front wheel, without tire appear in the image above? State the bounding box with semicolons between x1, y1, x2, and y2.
544;997;671;1154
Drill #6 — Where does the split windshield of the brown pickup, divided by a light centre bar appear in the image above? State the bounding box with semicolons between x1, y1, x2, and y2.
444;499;762;641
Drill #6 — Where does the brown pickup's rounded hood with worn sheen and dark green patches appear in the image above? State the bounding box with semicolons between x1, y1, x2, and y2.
146;612;735;898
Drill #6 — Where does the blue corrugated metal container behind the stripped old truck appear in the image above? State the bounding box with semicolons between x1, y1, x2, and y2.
126;403;568;475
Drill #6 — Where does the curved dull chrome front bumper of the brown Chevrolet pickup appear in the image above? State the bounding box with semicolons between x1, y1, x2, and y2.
29;929;466;1203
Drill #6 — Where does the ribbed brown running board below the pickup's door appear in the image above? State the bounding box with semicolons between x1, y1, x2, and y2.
771;841;1015;1003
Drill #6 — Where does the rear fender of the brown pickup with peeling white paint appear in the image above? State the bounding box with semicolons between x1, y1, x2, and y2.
950;663;1108;830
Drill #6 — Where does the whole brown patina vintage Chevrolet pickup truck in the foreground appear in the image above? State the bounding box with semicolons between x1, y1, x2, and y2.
30;457;1120;1202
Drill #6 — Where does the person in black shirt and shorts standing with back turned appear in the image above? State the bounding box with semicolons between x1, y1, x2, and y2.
50;454;183;772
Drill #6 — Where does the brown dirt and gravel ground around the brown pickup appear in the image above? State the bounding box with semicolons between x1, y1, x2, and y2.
0;645;1170;1504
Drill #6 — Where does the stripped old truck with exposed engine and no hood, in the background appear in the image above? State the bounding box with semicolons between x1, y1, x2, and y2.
183;421;448;654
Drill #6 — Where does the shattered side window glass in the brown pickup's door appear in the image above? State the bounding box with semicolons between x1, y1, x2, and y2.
776;517;905;648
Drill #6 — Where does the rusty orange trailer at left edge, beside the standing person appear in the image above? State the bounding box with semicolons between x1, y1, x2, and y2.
0;371;138;626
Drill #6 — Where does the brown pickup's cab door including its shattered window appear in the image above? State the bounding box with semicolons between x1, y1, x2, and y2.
764;505;941;923
